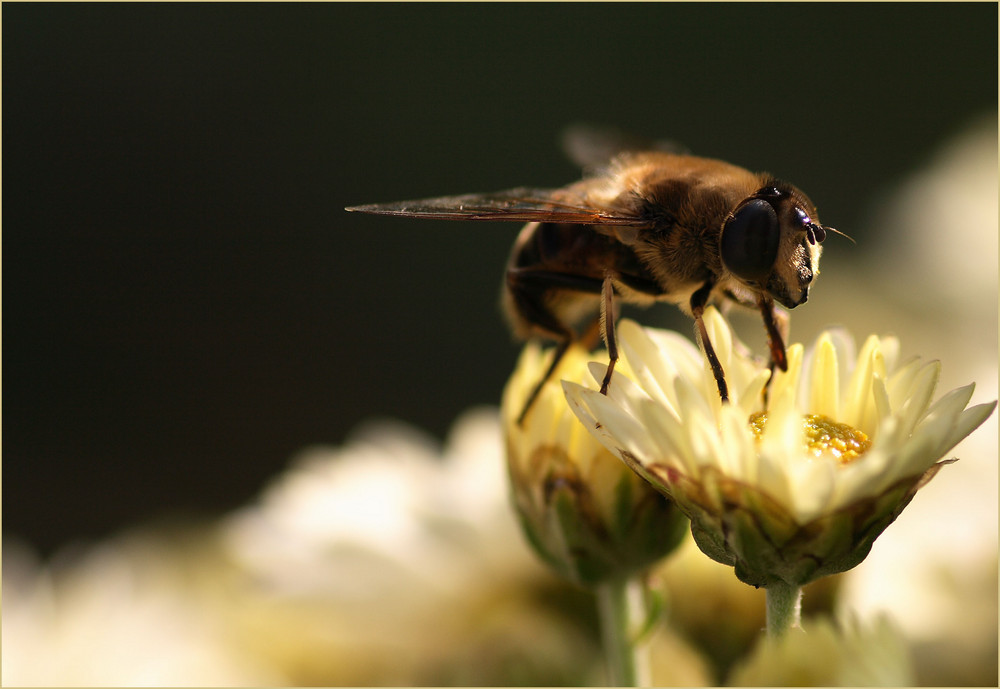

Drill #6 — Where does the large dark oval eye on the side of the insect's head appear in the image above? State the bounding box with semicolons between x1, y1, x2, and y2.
721;199;781;283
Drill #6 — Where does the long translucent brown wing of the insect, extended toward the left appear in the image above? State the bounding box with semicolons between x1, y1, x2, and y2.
346;187;649;226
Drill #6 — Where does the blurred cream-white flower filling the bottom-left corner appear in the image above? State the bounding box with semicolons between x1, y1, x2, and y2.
3;530;287;687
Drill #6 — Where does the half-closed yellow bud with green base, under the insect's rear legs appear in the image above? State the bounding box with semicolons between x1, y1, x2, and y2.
501;344;688;586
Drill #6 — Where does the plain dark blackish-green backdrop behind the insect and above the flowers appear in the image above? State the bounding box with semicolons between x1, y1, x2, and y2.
3;3;997;550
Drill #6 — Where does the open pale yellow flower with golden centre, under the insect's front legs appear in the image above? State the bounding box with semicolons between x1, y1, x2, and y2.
564;309;996;586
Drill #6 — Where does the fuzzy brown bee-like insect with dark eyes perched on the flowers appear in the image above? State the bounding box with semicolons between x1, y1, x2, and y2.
347;128;836;421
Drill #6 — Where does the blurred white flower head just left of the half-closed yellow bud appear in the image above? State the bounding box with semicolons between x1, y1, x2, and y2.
225;410;533;597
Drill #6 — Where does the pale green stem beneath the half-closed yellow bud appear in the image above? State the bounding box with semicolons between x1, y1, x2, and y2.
594;579;649;687
